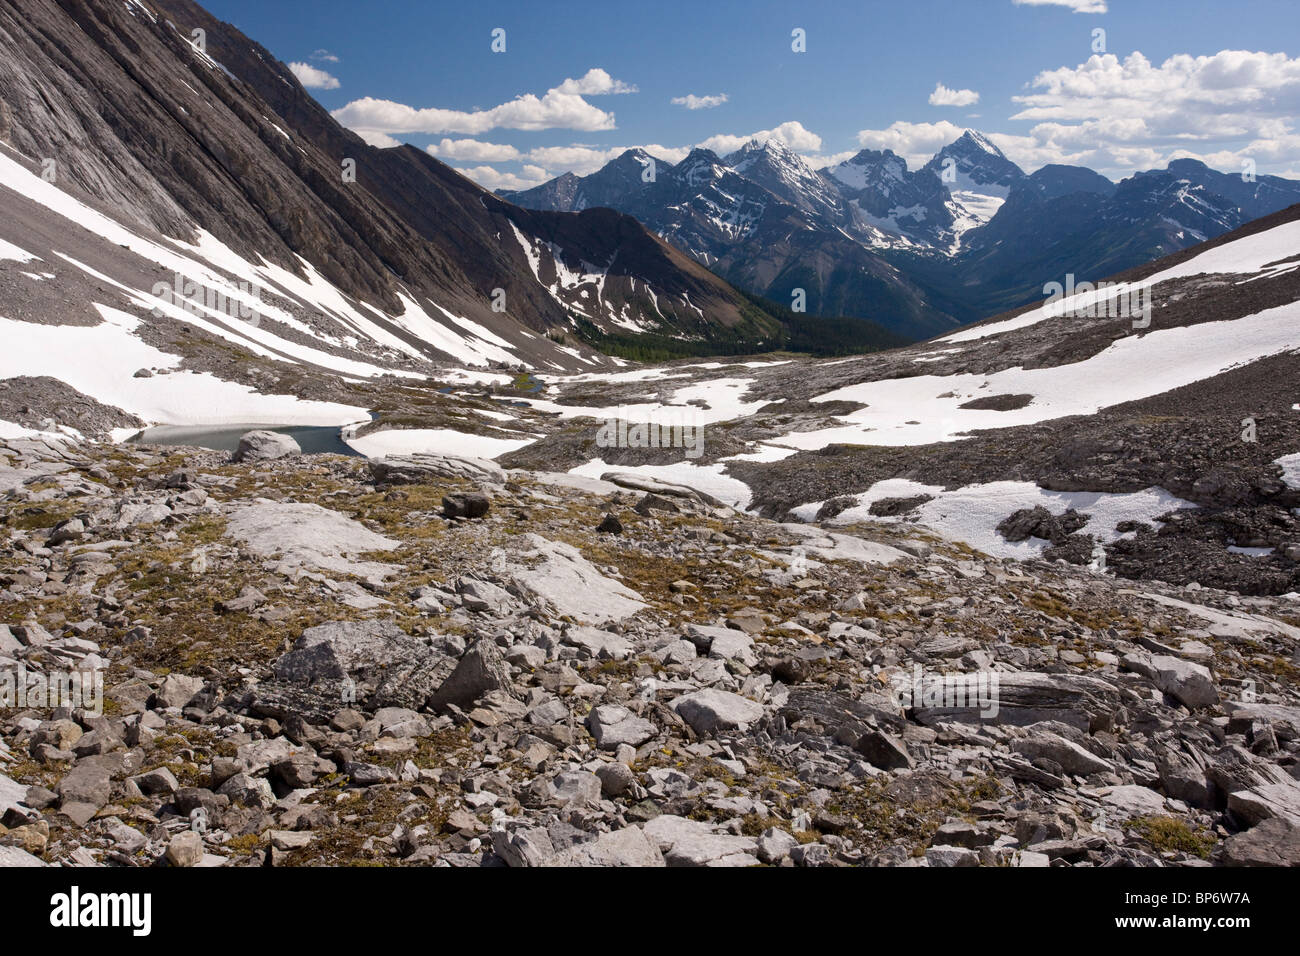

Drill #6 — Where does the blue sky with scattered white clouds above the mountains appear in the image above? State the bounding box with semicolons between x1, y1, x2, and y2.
207;0;1300;189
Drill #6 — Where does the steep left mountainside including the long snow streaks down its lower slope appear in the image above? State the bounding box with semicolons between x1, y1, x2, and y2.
0;0;781;390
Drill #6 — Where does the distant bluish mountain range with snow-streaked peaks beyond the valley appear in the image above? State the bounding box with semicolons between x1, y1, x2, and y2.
501;130;1300;338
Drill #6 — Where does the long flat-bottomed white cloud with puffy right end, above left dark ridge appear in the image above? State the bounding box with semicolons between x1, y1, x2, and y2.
333;69;636;134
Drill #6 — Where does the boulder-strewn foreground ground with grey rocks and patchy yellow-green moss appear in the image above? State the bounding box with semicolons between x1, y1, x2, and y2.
0;440;1300;866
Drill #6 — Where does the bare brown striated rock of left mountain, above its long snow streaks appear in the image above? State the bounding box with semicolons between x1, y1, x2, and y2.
0;0;780;367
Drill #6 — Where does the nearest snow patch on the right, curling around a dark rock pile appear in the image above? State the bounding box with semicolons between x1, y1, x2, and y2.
792;479;1196;559
